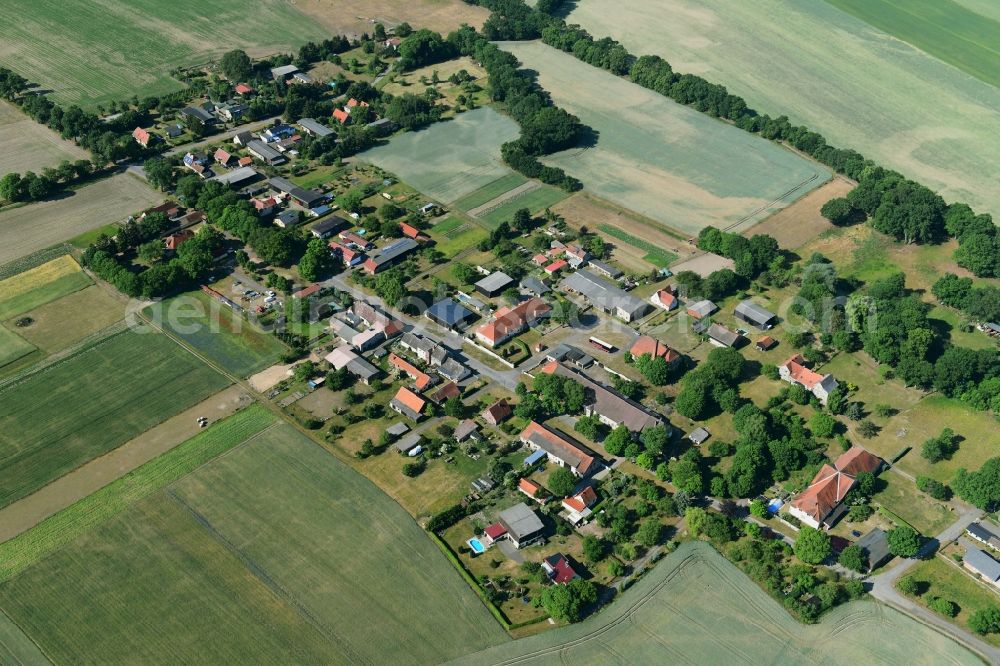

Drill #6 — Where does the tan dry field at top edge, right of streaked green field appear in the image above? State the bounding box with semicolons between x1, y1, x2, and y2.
295;0;490;36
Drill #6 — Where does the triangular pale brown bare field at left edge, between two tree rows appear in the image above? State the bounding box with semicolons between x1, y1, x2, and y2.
0;101;90;176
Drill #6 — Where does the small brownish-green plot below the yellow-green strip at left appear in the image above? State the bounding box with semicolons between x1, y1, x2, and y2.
4;285;125;354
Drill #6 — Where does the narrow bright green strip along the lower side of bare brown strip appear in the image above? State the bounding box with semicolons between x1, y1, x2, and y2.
0;405;276;581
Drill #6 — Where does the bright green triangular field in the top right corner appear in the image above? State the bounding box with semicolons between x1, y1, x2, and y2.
826;0;1000;86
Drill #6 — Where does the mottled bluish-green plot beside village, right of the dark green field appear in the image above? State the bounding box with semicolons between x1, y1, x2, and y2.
144;291;285;377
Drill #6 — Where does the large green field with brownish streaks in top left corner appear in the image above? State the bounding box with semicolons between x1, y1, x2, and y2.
0;0;329;107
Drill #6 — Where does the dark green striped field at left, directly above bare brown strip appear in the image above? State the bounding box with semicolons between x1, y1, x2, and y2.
0;329;229;506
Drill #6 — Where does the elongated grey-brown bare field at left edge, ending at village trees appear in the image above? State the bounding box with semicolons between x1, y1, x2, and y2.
0;174;163;264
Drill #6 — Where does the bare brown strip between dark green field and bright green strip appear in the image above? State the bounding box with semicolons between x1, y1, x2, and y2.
0;386;251;542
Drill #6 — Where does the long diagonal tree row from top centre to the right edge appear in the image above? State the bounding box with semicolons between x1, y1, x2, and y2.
476;0;1000;277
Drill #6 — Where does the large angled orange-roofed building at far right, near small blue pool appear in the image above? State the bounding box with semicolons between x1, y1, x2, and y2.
789;446;882;529
